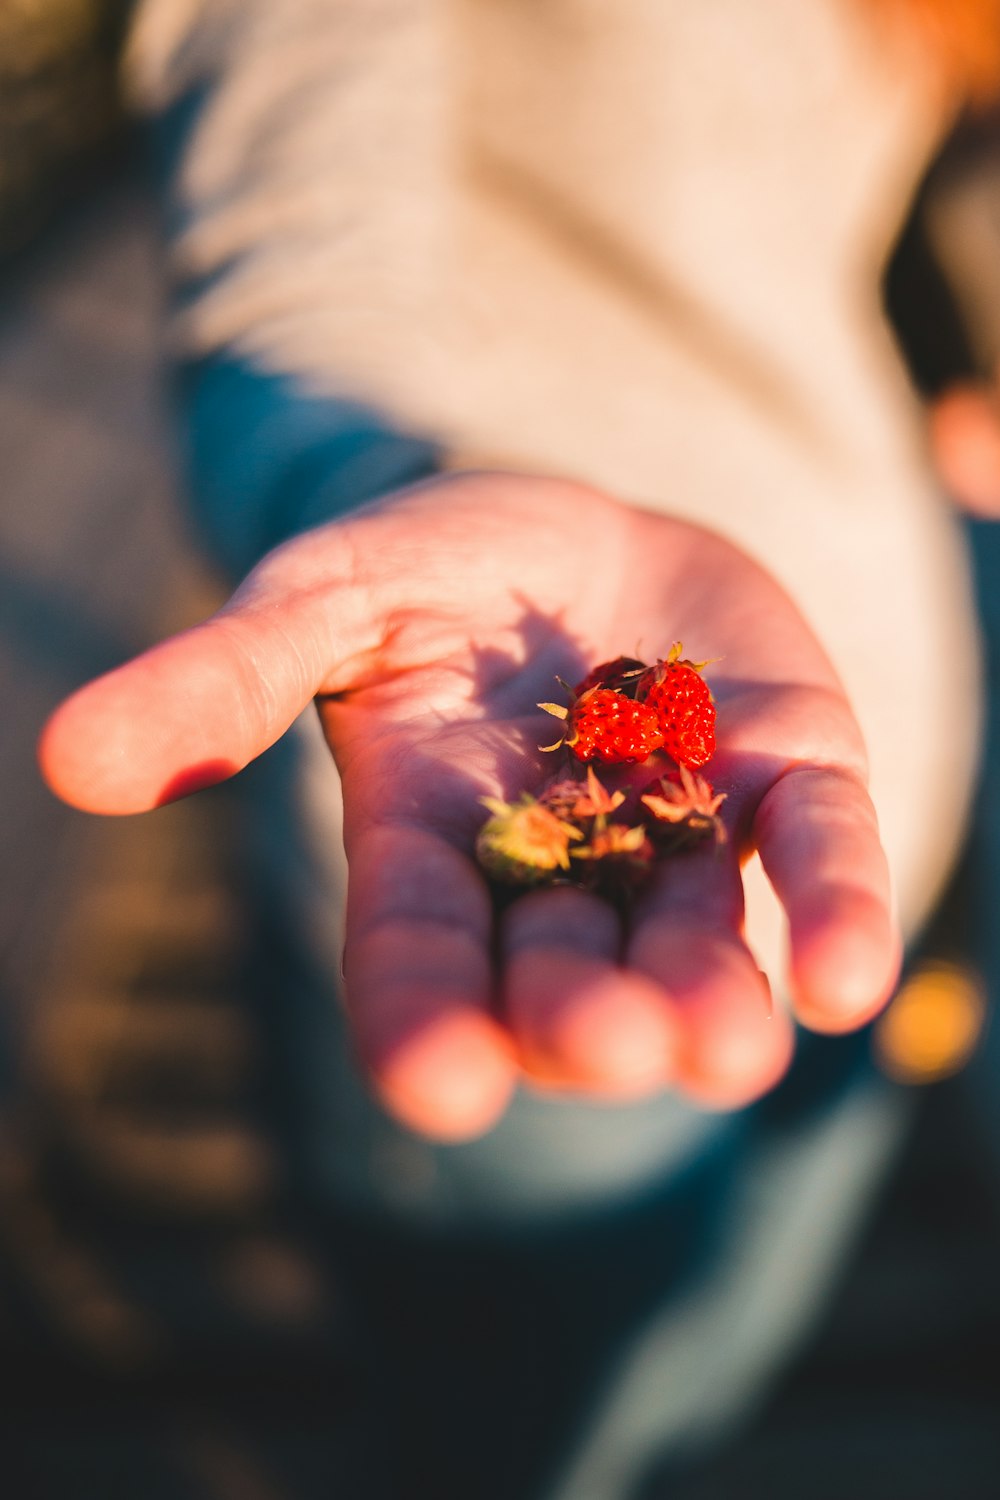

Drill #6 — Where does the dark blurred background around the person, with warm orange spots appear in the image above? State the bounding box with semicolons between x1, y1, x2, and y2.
0;0;1000;1500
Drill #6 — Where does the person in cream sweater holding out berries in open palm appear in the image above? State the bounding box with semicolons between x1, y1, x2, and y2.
40;0;1000;1500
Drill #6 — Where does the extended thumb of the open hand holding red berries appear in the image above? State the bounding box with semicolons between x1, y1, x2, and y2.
39;528;372;813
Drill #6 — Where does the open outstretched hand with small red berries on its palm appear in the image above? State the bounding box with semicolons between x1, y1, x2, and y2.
40;474;898;1140
